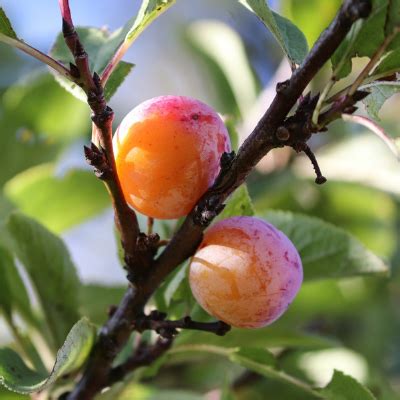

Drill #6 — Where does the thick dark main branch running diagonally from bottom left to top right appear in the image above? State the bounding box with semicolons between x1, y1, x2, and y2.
66;0;371;400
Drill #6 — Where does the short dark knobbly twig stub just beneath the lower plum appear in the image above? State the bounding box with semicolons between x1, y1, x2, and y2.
133;311;231;338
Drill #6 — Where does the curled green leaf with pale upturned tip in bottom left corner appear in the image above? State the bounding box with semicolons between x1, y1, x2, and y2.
0;318;96;393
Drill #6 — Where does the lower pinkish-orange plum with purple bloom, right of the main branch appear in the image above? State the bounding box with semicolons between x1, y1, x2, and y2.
189;217;303;328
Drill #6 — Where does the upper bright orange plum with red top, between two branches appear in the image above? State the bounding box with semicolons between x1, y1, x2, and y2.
113;96;231;219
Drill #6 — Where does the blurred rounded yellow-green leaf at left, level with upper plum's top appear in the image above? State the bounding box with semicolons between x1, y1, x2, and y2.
3;73;89;142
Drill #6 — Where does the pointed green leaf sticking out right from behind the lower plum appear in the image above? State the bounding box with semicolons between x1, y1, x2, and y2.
264;211;389;281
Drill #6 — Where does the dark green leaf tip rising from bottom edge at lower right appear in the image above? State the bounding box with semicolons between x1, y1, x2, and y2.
320;370;376;400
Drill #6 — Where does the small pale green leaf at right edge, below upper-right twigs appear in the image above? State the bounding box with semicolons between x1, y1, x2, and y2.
363;81;400;121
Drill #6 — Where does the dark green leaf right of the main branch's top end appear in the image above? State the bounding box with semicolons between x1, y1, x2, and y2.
331;0;387;79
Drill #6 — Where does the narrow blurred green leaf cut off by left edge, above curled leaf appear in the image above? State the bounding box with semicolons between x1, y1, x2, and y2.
0;246;37;326
